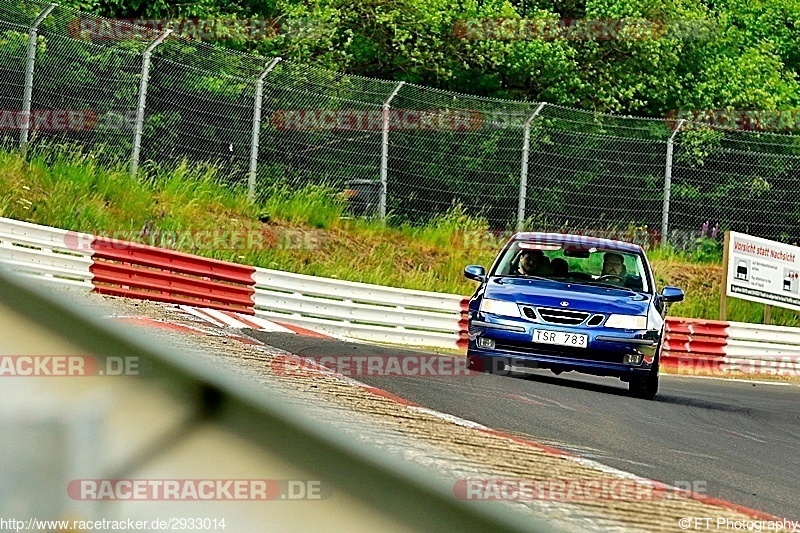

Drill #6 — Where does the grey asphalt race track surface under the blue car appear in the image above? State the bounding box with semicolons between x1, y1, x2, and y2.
248;331;800;520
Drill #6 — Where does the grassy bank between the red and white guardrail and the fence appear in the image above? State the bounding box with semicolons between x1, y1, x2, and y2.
0;146;800;326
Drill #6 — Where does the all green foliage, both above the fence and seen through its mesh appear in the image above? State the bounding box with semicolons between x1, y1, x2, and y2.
0;0;800;245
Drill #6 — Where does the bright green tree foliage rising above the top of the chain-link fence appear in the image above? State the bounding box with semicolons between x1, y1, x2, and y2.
51;0;800;112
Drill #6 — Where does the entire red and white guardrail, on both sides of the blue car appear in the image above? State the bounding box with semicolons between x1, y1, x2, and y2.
0;214;800;368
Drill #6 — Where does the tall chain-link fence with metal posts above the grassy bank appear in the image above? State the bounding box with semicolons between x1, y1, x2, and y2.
0;0;800;247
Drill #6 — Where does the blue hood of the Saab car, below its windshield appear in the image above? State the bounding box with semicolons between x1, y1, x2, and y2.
483;276;650;315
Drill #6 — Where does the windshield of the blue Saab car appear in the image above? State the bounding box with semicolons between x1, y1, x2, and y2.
491;241;650;292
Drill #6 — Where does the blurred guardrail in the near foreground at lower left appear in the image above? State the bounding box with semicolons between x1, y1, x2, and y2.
0;245;559;531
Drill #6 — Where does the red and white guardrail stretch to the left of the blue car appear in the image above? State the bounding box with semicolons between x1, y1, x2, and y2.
0;218;467;350
